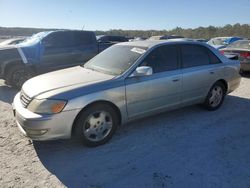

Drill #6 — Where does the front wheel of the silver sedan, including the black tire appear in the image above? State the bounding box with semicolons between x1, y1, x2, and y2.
74;103;119;147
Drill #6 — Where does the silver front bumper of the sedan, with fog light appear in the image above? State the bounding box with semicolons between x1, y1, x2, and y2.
13;93;80;140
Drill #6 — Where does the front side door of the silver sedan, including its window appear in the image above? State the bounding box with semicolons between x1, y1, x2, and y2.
125;45;182;118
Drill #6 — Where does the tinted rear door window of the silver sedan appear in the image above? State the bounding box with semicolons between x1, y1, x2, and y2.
181;45;209;68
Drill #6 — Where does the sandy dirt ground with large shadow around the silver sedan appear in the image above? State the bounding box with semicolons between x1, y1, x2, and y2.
0;75;250;188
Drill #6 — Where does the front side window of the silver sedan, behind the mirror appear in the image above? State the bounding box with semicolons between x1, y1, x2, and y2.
143;45;178;73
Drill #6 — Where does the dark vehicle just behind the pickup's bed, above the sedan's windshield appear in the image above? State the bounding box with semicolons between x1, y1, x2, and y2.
96;35;128;51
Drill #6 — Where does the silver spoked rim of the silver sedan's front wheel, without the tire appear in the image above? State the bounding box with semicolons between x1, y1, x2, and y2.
83;111;113;142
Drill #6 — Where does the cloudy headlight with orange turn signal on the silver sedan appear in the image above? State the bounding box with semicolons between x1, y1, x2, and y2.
28;99;67;114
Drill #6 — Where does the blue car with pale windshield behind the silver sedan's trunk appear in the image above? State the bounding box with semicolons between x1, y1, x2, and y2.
207;37;243;49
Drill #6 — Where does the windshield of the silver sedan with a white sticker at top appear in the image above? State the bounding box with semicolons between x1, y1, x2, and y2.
84;45;146;75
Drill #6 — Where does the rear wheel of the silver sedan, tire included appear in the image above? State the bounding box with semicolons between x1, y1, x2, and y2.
203;82;226;111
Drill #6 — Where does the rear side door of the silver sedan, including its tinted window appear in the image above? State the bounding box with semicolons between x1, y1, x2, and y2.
181;44;223;104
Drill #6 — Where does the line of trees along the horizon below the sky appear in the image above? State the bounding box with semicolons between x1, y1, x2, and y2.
0;23;250;39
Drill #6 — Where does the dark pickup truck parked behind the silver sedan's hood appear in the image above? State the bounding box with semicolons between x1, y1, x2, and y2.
0;30;108;88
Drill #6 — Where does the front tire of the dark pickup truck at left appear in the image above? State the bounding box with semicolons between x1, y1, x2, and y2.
6;65;31;89
